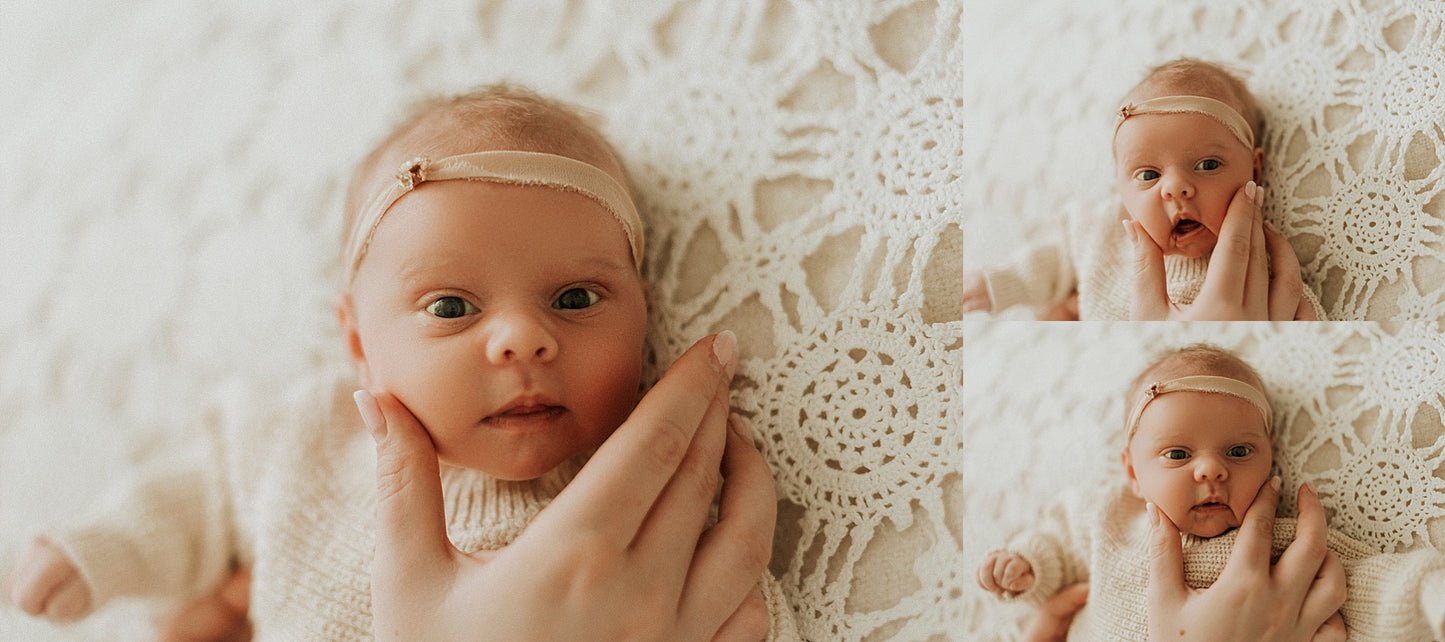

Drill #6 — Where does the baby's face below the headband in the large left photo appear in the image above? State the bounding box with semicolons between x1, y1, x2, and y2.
350;181;647;480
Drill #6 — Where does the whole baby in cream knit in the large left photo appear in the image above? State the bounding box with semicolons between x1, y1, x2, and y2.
7;85;796;641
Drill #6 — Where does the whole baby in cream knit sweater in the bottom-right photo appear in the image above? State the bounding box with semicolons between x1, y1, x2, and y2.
978;346;1445;641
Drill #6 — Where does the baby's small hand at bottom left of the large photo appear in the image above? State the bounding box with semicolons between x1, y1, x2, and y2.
0;539;91;622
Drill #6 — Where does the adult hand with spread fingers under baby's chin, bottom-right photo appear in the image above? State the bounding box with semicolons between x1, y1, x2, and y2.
1147;477;1345;642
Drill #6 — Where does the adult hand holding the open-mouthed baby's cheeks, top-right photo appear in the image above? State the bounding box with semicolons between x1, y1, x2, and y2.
1124;181;1314;321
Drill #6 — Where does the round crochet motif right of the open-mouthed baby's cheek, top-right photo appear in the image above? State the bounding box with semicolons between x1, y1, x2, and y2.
1325;176;1425;279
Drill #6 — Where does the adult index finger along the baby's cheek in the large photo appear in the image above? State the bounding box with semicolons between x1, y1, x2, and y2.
546;333;737;547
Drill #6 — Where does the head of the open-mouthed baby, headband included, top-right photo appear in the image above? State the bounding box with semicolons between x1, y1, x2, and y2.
1114;58;1264;257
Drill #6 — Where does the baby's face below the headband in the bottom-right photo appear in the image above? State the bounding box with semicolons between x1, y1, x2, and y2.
1124;392;1273;538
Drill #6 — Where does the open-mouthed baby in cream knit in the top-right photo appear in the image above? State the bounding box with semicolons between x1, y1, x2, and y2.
964;59;1325;321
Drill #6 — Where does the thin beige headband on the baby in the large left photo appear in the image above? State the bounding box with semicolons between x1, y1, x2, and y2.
347;150;643;278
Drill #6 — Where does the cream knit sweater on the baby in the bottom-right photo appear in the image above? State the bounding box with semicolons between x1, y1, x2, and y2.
1007;484;1445;642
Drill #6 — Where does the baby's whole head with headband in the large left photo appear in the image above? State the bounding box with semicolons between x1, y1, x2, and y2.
338;85;647;480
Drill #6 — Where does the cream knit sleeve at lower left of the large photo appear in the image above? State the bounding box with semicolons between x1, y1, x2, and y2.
42;430;231;607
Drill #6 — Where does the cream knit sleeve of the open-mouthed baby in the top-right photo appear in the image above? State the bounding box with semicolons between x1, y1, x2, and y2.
984;240;1078;312
